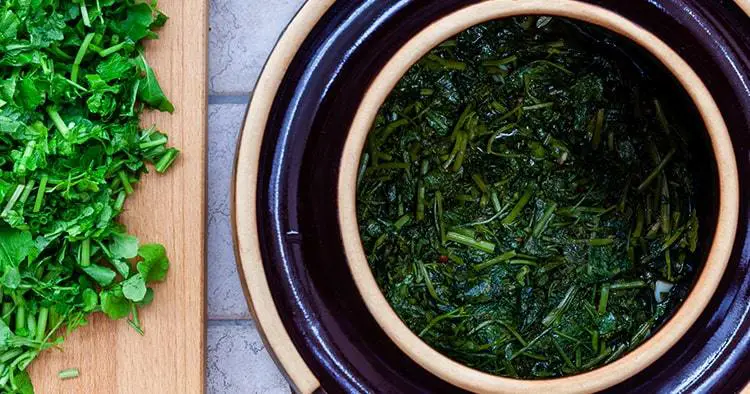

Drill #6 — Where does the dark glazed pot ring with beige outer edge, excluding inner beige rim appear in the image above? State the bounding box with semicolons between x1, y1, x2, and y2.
234;0;750;392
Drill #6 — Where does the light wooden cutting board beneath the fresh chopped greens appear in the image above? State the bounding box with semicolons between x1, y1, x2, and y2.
30;0;208;394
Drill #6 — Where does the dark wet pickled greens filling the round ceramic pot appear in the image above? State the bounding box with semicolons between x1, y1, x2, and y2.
357;17;698;379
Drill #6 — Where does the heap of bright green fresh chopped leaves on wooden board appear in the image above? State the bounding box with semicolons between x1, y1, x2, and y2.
0;0;178;393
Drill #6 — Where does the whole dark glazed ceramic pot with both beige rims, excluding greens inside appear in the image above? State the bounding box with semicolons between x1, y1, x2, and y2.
234;0;750;392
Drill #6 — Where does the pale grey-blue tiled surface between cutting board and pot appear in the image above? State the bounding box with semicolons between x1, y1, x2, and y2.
206;0;304;394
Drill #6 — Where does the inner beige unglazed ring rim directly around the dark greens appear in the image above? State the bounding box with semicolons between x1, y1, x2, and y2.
338;0;739;393
